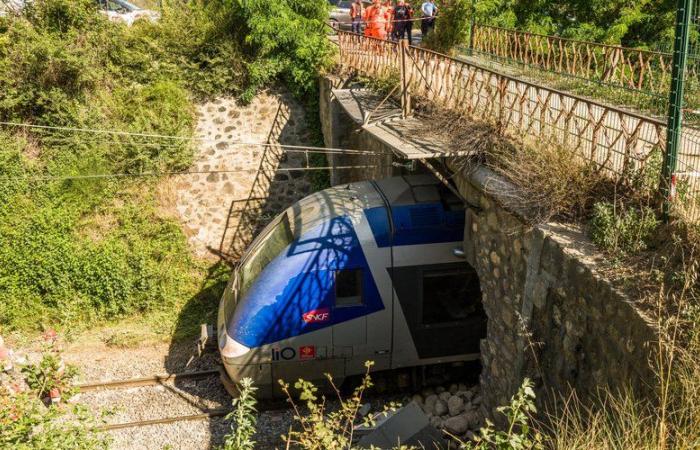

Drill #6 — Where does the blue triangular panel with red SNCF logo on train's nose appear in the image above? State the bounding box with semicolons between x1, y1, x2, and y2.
228;216;386;348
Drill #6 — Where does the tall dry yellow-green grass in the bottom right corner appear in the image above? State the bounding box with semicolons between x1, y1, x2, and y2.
548;255;700;450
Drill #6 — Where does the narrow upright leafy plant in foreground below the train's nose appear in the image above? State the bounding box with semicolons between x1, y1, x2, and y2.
221;378;257;450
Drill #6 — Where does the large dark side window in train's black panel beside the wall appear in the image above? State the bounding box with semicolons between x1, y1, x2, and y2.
421;268;482;325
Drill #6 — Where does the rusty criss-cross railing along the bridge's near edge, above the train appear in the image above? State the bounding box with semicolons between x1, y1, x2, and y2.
338;32;700;219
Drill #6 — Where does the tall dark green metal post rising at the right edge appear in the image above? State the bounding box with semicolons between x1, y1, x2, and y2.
661;0;693;222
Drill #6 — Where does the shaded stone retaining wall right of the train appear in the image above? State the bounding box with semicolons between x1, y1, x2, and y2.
455;168;656;416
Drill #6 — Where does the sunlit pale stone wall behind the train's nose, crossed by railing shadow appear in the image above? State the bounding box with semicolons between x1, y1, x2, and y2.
172;90;318;259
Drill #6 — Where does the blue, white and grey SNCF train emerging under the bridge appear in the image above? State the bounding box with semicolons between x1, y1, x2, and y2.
217;175;486;397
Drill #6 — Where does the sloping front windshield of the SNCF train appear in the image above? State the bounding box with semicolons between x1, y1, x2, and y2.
238;212;294;297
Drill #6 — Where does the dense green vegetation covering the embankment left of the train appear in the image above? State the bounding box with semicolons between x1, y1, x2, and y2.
0;0;331;336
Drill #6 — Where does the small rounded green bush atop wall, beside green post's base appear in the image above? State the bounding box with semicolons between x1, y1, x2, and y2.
590;202;659;254
